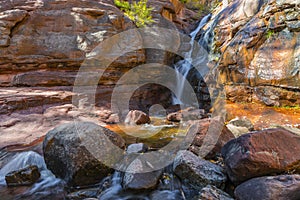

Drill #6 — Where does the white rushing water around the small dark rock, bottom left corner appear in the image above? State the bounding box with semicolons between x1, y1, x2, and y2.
0;151;64;199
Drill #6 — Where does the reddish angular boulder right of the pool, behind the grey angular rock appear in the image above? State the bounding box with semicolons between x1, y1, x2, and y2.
189;118;235;159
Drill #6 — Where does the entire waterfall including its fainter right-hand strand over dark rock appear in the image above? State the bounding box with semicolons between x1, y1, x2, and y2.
172;0;228;105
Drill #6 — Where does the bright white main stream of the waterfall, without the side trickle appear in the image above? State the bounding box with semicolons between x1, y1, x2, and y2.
172;14;211;105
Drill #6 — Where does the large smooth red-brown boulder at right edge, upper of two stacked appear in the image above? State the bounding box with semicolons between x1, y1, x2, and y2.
222;128;300;184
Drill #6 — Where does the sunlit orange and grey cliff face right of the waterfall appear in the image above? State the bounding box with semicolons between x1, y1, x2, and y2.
204;0;300;106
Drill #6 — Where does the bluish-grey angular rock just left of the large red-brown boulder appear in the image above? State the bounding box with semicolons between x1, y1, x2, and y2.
173;151;227;189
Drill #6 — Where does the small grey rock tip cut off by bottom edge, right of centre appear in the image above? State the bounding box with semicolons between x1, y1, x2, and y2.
193;185;233;200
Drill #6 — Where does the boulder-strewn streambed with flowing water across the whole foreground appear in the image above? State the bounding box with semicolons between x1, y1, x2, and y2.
0;109;300;200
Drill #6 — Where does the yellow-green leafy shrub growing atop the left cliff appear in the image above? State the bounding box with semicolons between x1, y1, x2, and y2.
114;0;154;27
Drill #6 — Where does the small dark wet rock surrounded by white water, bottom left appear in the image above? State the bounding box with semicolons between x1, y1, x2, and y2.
5;165;41;186
